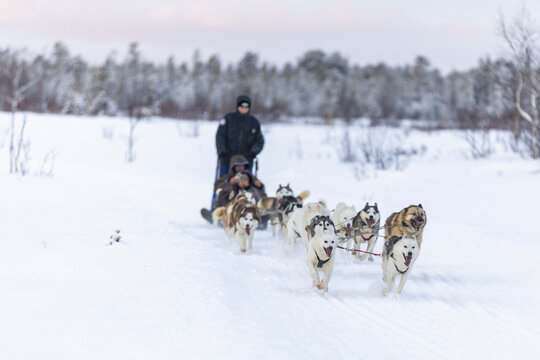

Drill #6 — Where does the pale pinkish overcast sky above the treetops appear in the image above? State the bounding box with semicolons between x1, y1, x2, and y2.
0;0;540;72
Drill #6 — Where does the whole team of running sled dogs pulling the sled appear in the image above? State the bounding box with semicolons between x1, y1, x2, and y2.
213;184;427;293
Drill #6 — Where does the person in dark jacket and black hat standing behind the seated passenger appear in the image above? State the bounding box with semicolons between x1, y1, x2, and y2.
201;95;264;222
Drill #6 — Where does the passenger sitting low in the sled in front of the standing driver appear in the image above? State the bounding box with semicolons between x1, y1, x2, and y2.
212;155;266;211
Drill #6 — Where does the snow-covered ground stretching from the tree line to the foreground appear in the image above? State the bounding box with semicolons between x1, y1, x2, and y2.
0;113;540;360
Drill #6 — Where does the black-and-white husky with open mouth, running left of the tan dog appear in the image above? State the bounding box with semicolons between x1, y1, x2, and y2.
352;202;381;261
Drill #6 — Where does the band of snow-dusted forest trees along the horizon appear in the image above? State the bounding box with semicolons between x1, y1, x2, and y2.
0;42;516;128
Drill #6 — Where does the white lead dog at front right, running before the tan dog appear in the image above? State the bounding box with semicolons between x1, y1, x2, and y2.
382;235;420;294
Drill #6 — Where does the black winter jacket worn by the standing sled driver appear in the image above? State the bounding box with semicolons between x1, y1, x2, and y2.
216;111;264;167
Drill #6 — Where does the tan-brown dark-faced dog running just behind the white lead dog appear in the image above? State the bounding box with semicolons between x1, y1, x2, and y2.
385;204;427;248
